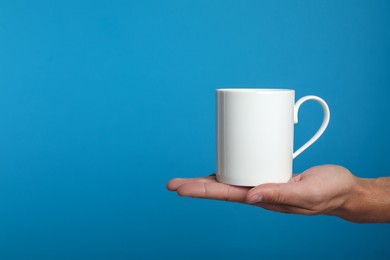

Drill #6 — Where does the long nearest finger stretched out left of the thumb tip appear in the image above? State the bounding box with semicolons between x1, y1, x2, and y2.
177;181;250;202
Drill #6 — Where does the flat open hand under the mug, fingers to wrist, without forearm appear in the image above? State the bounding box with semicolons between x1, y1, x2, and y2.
167;165;357;219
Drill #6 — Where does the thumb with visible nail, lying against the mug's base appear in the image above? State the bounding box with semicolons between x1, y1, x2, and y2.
246;182;302;205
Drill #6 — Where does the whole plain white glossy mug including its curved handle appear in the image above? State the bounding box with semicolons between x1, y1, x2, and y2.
216;89;330;186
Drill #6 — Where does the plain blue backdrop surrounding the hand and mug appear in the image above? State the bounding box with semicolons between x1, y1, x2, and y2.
0;0;390;259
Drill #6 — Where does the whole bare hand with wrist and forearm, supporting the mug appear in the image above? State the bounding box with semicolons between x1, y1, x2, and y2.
167;165;390;223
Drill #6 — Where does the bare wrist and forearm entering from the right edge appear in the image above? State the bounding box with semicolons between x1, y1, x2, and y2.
335;177;390;223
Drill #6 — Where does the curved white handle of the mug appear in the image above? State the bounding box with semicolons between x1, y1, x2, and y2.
293;96;330;159
